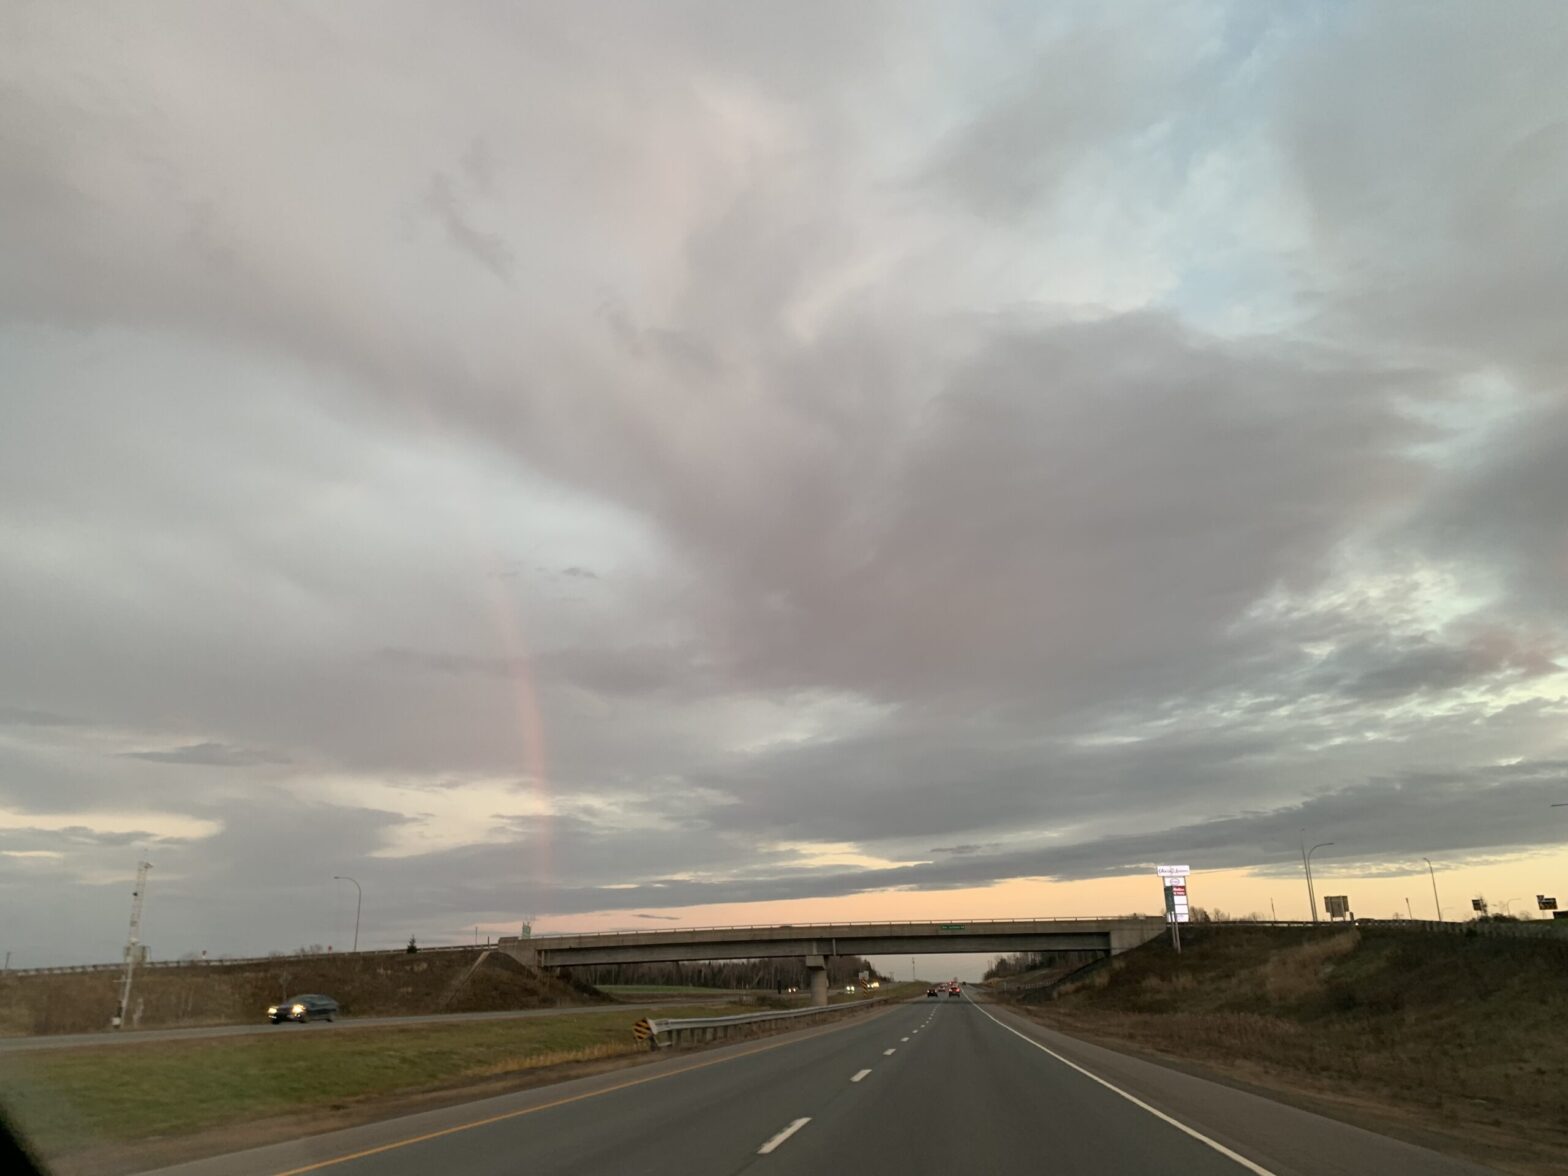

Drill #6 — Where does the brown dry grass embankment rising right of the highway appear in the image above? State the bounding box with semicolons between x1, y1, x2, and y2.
1003;925;1568;1171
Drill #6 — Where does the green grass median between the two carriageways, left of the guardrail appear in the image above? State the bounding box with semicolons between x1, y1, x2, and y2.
0;1005;756;1156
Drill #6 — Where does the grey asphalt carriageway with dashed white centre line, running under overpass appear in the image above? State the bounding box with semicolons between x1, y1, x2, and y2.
141;996;1485;1176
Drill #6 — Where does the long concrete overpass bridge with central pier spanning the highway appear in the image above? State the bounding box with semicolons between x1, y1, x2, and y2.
500;917;1167;1005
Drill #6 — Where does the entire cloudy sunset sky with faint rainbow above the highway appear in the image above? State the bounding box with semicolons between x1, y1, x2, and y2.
0;0;1568;971
